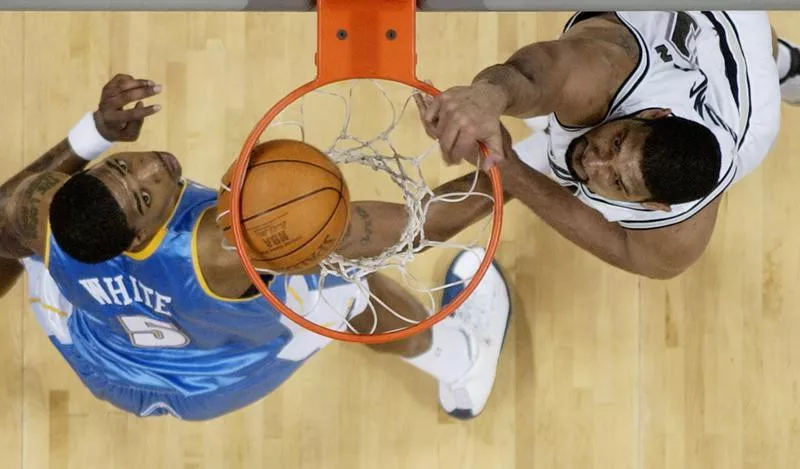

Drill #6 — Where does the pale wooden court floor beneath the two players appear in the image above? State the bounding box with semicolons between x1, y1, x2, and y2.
0;13;800;469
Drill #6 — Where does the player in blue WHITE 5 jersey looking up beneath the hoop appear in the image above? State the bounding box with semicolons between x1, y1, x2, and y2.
0;75;510;420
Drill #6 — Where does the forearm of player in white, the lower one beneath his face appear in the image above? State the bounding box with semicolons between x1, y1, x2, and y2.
502;159;649;275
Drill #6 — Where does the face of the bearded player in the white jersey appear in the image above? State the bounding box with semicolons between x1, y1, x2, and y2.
567;119;651;202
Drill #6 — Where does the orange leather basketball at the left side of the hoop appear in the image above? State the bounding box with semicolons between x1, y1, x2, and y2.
217;140;350;273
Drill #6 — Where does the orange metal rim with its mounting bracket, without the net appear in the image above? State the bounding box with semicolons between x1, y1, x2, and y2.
230;0;503;344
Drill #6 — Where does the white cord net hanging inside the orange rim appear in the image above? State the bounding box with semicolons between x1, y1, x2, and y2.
227;79;494;334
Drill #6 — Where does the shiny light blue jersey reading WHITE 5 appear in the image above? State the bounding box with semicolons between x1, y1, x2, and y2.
26;182;356;419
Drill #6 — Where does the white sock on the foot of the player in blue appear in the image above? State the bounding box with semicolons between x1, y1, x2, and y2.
403;318;472;383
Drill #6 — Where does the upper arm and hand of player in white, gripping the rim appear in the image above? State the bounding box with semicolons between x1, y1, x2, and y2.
422;16;639;163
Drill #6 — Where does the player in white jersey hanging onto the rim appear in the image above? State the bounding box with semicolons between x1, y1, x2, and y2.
418;11;800;278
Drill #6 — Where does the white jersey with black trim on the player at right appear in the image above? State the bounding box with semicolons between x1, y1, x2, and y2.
518;11;780;229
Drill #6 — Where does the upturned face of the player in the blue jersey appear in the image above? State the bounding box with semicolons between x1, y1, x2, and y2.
89;151;182;250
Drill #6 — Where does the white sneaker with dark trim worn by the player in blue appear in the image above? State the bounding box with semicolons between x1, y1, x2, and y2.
439;249;511;420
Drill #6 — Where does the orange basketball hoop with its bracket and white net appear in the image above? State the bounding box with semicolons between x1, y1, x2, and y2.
230;0;503;344
